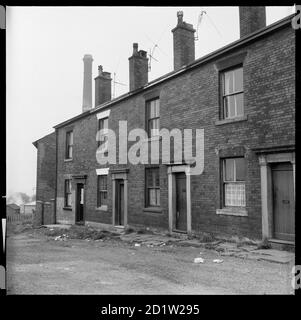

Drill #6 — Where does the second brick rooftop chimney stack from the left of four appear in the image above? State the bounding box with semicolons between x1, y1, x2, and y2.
129;43;148;91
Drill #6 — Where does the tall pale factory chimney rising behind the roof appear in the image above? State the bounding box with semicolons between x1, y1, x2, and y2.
83;54;93;112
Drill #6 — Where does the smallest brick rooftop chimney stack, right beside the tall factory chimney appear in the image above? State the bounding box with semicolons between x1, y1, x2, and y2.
94;66;112;107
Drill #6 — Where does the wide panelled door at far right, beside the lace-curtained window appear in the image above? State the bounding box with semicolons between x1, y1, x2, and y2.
272;163;295;241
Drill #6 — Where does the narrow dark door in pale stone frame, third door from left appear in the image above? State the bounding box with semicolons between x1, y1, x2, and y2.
175;172;187;232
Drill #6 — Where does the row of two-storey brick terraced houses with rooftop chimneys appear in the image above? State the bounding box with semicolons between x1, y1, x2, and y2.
34;7;295;244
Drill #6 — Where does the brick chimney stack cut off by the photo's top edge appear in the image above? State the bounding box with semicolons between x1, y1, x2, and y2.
239;6;266;38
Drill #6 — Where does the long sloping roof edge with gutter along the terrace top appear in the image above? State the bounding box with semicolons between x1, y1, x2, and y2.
53;13;295;129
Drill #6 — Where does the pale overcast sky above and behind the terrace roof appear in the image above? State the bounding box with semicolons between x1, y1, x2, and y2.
6;7;292;195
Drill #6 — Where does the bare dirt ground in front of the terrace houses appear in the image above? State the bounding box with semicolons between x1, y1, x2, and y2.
7;225;293;294
